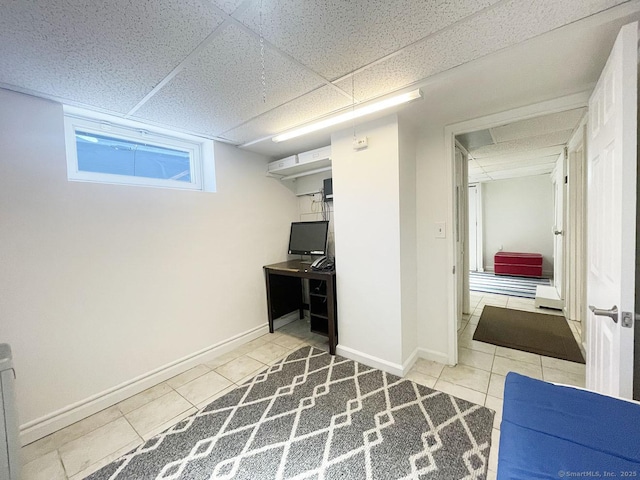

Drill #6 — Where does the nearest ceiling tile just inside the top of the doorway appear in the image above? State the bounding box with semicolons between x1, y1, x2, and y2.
491;108;587;143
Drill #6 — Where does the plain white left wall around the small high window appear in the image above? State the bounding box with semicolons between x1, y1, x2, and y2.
0;90;298;440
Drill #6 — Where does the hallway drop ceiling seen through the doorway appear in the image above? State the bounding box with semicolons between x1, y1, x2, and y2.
456;108;586;183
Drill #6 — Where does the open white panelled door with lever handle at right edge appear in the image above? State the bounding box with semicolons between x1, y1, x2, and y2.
587;22;638;398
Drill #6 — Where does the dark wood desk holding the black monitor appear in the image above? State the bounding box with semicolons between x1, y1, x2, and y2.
263;260;338;355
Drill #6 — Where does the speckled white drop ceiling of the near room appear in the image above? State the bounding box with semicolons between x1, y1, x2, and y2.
0;0;640;157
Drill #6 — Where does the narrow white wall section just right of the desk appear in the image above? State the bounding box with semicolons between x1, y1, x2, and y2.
331;115;403;370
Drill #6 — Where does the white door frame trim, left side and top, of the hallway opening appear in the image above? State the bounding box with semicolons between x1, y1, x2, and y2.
444;90;591;365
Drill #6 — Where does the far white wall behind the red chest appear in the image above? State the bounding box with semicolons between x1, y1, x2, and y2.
482;175;554;275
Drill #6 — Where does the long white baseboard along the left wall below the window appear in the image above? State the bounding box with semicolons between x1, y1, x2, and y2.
20;325;269;445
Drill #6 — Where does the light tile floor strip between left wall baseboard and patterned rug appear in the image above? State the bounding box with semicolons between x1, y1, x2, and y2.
22;321;329;480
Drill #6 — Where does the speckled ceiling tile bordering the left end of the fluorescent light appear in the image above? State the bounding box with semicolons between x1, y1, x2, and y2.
221;86;350;143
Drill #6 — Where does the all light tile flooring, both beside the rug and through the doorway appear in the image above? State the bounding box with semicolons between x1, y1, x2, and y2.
22;295;585;480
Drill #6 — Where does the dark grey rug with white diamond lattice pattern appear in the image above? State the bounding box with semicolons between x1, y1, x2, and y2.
87;347;494;480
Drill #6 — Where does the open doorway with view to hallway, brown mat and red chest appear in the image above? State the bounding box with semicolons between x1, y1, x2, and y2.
444;95;586;386
